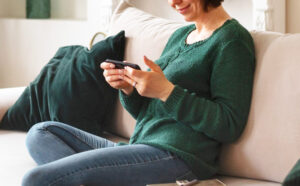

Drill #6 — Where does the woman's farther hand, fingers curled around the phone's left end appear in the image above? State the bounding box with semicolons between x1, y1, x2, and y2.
100;62;133;95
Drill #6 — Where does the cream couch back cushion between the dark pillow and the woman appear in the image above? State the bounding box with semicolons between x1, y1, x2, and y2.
109;1;184;138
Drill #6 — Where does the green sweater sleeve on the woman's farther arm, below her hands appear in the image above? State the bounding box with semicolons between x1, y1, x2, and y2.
119;89;149;119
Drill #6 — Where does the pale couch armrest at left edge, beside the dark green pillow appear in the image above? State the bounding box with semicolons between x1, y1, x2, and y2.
0;87;25;121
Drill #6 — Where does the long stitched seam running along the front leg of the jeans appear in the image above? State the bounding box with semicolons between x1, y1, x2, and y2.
48;155;177;186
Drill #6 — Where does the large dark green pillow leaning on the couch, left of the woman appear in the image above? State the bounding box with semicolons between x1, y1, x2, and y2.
0;31;125;134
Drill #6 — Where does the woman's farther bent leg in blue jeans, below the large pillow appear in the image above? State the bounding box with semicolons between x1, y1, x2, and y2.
26;121;115;165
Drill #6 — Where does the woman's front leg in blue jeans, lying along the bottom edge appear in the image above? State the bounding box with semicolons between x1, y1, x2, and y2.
23;145;196;186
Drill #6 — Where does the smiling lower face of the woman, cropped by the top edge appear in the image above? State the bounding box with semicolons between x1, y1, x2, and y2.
168;0;204;21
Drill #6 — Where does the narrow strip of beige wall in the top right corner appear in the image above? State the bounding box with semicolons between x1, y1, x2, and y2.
286;0;300;33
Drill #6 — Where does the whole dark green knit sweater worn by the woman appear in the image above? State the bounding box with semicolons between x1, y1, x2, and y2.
120;19;255;179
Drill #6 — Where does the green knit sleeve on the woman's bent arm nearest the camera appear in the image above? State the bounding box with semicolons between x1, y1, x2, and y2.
161;41;255;143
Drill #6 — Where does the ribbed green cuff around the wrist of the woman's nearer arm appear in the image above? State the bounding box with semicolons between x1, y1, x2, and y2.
164;85;186;111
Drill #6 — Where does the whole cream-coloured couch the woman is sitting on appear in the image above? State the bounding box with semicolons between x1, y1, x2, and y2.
0;2;300;186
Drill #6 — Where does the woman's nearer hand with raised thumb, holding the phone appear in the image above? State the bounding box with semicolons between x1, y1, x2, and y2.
124;56;174;101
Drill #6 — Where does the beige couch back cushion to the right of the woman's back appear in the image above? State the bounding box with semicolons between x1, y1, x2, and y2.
221;32;300;182
